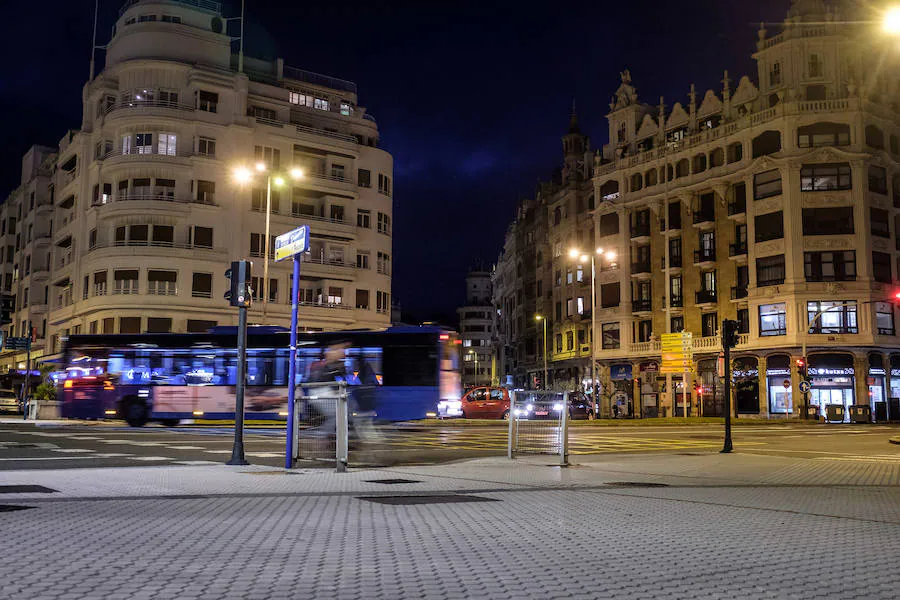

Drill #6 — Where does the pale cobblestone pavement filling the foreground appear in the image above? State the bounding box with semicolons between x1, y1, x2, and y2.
0;454;900;600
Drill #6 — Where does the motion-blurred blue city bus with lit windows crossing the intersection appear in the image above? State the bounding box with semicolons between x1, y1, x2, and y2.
57;326;462;427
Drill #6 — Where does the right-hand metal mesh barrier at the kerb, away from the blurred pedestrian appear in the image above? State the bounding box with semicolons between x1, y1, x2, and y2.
507;391;570;466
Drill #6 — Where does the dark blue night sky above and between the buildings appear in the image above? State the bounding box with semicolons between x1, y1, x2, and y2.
0;0;790;323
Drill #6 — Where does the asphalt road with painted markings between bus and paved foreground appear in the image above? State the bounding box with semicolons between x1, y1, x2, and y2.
0;422;900;470
